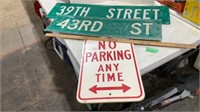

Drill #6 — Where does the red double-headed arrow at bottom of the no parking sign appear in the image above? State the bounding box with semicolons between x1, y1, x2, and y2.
89;84;130;94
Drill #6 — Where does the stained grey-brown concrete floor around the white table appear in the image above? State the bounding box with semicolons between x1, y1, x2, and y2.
0;0;199;111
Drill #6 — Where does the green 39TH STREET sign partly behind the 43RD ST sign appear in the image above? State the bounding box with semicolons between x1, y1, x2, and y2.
47;3;170;24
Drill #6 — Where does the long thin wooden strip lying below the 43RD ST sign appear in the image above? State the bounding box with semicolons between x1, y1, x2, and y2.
45;33;196;49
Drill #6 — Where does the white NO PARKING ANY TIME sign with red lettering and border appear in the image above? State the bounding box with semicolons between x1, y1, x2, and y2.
77;40;145;103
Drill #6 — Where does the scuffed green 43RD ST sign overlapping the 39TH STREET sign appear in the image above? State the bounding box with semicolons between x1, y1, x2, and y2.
45;16;162;40
